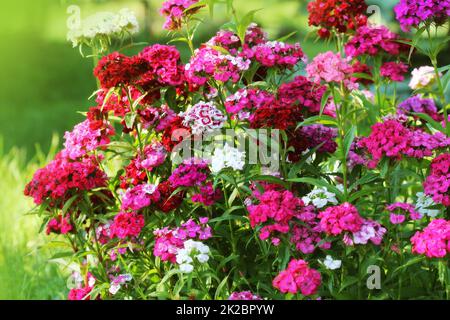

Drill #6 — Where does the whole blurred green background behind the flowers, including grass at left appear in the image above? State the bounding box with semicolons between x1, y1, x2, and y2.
0;0;444;299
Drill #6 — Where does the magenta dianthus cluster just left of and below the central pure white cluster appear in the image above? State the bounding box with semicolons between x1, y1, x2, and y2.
169;158;211;188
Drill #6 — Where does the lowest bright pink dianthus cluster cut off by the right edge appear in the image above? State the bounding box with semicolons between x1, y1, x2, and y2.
411;219;450;258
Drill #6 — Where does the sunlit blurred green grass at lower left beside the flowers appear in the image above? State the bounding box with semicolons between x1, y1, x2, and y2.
0;138;67;300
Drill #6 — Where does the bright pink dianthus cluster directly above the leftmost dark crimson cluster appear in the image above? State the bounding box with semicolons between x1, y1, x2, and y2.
62;120;114;160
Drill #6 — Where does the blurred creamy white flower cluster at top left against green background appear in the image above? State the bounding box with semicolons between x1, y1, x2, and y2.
67;8;139;47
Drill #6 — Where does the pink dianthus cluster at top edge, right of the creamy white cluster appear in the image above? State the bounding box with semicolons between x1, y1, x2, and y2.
160;0;201;30
